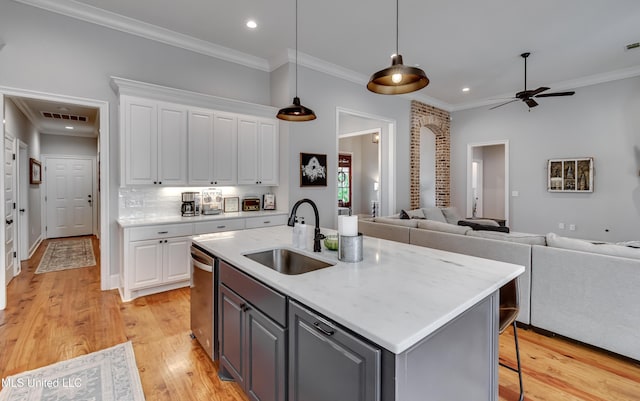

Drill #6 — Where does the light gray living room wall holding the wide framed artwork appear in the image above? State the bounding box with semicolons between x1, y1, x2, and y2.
451;77;640;241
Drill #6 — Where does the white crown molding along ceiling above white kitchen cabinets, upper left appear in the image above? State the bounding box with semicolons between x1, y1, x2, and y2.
13;0;270;72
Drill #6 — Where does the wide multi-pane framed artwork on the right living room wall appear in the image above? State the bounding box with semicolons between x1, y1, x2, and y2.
547;157;593;192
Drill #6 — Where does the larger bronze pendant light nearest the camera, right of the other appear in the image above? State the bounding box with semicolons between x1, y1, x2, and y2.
367;0;429;95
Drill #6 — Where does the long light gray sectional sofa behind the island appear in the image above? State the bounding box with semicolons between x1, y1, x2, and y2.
358;208;640;360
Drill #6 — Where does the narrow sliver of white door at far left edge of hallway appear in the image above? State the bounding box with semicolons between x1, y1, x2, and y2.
4;135;16;285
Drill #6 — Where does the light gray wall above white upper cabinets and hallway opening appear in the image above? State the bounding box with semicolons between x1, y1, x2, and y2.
0;1;272;274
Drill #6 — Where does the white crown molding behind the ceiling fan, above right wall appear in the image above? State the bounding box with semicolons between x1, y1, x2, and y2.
451;66;640;111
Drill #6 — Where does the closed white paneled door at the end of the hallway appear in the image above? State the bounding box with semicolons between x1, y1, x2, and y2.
44;158;93;238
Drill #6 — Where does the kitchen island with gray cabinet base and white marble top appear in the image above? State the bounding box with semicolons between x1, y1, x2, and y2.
194;227;524;401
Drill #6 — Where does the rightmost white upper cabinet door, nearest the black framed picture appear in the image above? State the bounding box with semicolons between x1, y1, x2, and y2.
258;121;280;185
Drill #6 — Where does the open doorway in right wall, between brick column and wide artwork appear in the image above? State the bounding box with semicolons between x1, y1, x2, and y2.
466;140;509;225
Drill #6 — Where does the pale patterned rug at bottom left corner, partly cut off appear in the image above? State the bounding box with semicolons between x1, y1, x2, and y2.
0;341;145;401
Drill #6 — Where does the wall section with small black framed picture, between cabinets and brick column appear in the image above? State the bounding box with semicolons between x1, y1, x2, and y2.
276;67;410;227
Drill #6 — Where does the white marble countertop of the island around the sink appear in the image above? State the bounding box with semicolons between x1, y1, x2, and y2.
194;226;524;354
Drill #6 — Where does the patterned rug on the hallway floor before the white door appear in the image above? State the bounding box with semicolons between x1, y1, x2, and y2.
36;238;96;274
